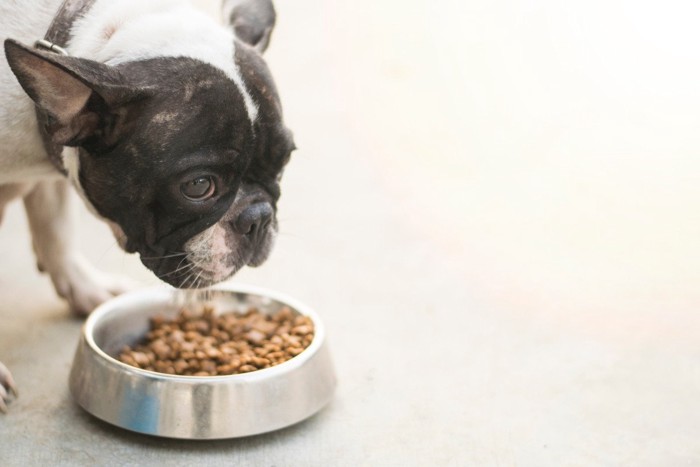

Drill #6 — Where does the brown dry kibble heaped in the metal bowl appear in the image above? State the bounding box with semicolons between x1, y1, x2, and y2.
119;307;314;376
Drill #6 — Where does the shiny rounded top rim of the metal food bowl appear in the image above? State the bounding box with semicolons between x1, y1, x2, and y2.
82;283;325;384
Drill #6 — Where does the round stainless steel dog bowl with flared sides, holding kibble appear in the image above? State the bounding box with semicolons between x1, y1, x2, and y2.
70;285;336;439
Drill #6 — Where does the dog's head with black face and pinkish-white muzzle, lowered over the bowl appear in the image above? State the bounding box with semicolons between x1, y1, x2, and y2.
5;2;294;287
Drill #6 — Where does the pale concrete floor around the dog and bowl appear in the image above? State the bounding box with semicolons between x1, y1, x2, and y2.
0;0;700;466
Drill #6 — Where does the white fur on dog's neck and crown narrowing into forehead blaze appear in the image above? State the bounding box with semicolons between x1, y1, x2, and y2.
68;0;258;123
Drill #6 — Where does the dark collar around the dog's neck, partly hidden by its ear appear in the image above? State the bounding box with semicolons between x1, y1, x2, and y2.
34;0;96;175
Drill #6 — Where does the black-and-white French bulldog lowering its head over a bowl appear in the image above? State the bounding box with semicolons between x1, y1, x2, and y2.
0;0;295;409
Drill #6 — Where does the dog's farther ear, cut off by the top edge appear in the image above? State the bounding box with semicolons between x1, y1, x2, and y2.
223;0;277;53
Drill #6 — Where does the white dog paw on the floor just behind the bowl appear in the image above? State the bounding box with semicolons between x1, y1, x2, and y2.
51;256;136;316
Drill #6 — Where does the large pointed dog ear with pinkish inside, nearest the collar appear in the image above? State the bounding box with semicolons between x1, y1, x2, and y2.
5;39;146;146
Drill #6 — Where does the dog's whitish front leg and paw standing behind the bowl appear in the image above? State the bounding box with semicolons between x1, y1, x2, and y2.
24;180;129;315
